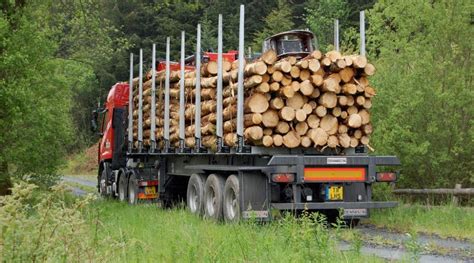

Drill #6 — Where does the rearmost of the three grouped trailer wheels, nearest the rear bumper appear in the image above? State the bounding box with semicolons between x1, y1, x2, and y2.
223;175;240;222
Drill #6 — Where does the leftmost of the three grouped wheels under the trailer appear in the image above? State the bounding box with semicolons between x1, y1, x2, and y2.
186;174;206;215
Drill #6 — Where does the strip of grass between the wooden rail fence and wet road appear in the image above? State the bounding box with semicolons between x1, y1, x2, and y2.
366;204;474;242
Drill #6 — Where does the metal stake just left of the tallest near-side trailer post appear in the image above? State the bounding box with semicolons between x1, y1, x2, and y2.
216;14;223;152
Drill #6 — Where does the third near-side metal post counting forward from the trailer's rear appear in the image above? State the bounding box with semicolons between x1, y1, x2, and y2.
194;24;201;152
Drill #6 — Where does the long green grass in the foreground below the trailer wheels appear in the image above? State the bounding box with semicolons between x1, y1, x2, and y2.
89;200;382;262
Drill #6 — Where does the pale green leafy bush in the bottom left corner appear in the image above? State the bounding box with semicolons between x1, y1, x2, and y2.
0;182;114;262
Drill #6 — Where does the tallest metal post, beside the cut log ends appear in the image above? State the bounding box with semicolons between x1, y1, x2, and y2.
237;5;245;152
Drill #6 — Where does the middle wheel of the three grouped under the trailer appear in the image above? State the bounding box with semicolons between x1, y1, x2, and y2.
204;174;224;220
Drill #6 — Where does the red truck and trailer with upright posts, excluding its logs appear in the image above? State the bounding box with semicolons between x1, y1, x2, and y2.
92;5;400;223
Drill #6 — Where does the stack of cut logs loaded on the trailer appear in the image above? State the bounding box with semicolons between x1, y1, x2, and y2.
133;50;375;153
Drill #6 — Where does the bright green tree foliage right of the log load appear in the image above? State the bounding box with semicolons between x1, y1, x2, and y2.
368;0;474;190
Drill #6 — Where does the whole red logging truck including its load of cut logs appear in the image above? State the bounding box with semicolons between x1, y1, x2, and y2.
92;6;400;223
